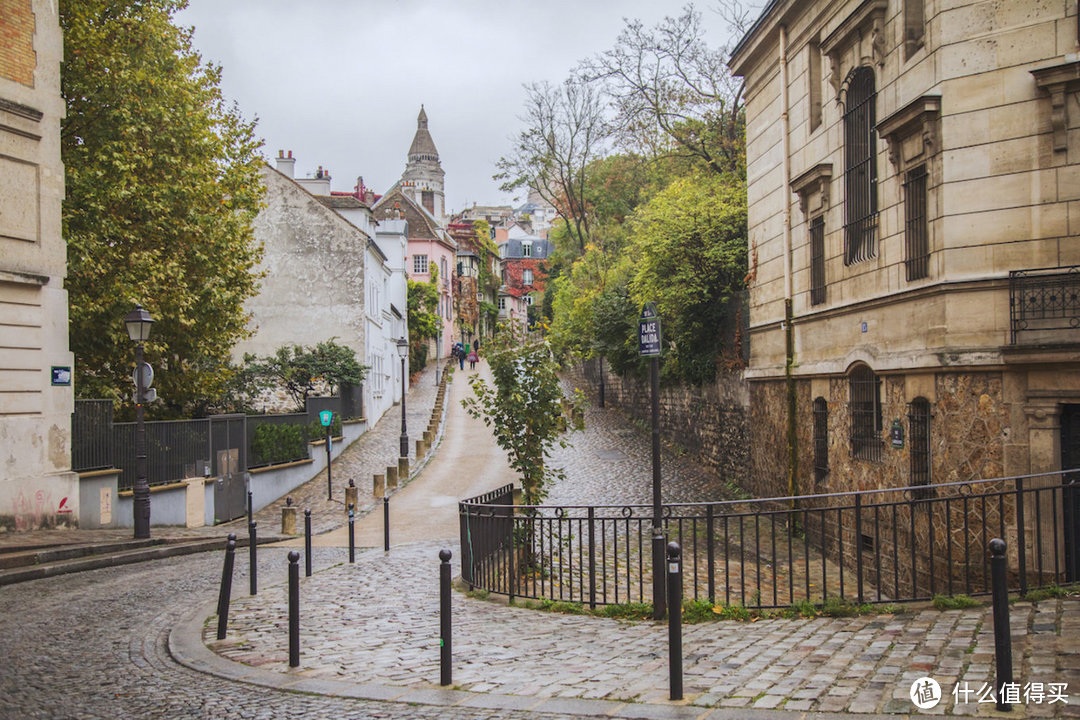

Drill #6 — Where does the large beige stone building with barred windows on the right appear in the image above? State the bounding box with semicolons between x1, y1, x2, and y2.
730;0;1080;507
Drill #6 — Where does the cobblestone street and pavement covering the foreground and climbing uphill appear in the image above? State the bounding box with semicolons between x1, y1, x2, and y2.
0;372;1080;720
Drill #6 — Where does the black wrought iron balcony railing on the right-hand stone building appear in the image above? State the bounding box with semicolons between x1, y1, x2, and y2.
1009;266;1080;345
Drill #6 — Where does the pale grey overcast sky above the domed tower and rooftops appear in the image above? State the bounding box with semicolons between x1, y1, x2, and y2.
176;0;743;213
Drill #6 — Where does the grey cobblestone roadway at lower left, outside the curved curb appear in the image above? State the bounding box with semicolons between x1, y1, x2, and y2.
0;549;591;720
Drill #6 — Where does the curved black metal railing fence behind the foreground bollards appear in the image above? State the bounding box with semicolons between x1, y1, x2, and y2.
459;472;1080;608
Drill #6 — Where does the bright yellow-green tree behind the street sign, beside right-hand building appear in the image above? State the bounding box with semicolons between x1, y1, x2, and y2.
630;174;746;383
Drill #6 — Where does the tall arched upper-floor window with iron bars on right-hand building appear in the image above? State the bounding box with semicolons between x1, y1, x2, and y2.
843;66;878;264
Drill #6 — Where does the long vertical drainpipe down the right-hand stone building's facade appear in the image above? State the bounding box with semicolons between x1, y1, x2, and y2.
780;25;799;500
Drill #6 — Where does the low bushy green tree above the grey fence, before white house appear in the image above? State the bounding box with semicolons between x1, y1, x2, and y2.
244;338;367;411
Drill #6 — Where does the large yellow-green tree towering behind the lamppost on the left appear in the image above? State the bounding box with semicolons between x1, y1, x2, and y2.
59;0;262;416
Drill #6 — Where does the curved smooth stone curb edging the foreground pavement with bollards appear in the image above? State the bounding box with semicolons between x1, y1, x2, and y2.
166;601;913;720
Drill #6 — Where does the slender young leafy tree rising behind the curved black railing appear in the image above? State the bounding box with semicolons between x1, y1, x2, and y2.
461;324;580;505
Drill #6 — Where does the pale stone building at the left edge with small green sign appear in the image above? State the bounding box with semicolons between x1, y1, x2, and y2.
0;0;77;531
